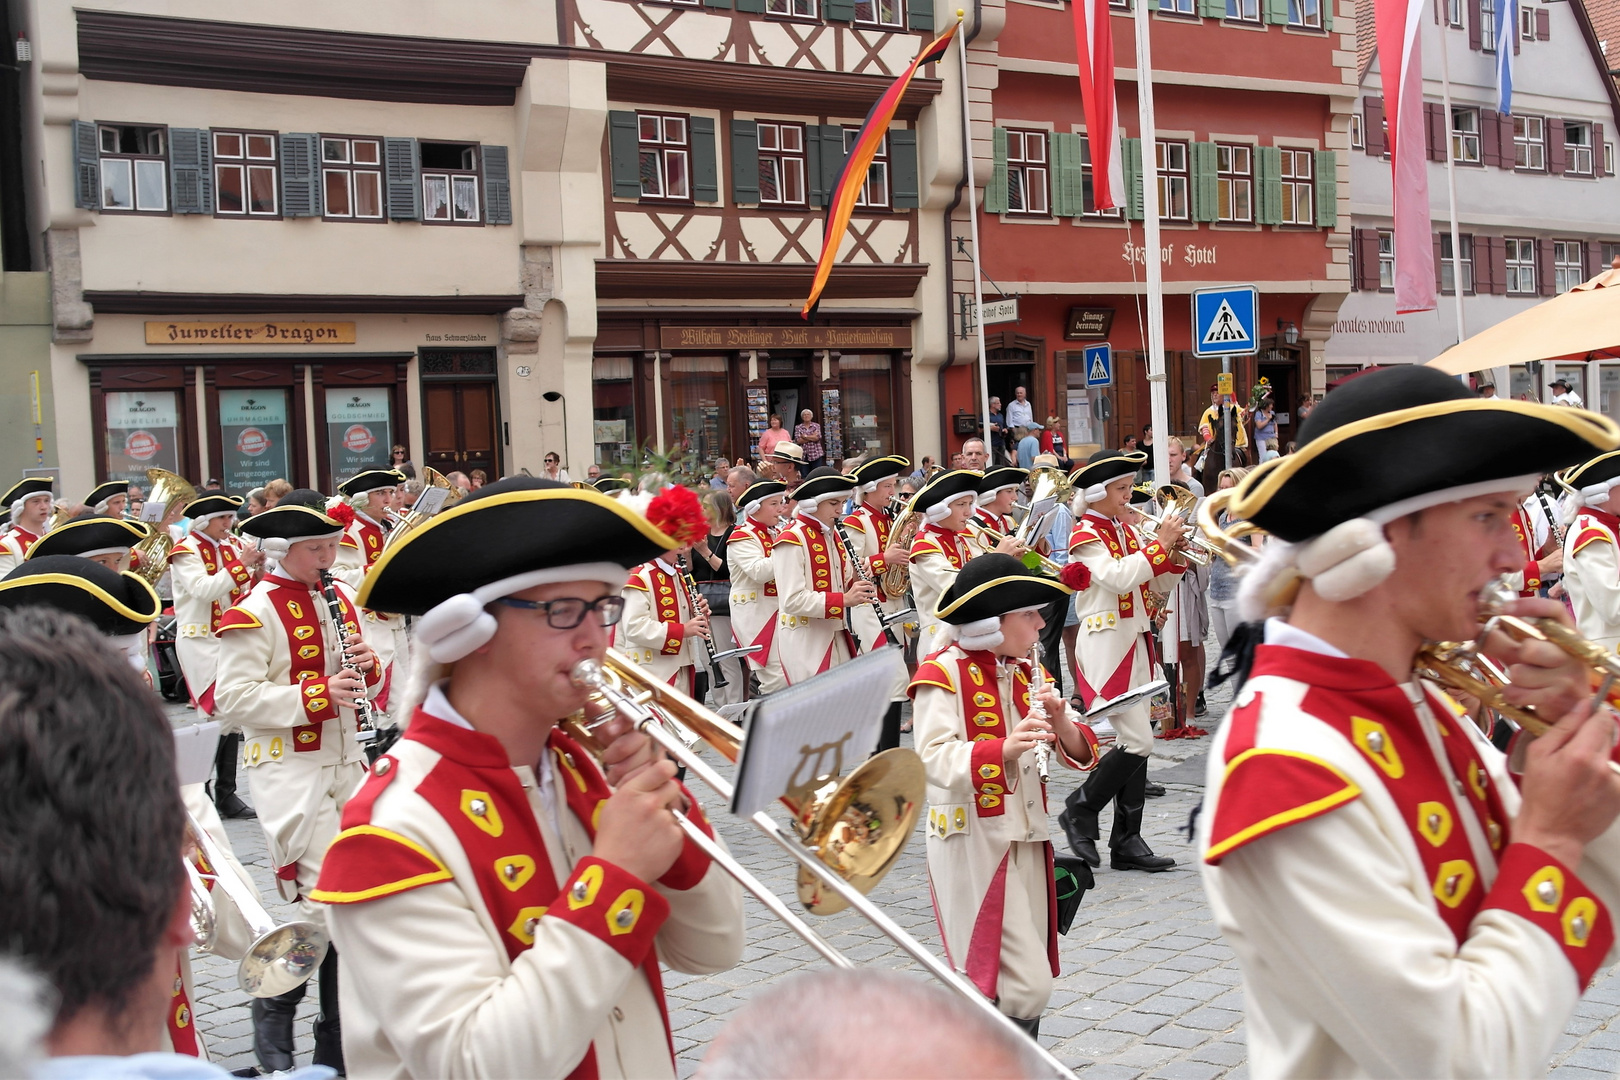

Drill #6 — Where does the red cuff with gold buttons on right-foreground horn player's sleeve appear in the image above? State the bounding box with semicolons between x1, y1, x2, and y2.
1484;844;1615;989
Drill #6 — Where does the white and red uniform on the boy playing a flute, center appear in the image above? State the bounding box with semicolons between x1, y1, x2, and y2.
909;644;1097;1018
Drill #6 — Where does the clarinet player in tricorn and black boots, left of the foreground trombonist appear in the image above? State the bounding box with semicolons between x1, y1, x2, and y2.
214;487;381;1074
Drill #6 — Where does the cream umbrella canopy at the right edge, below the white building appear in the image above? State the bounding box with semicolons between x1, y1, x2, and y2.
1429;269;1620;376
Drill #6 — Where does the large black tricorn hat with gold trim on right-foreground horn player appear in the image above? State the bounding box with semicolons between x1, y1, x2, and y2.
1231;364;1620;542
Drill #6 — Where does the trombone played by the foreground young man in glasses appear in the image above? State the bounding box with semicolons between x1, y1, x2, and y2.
562;649;1074;1077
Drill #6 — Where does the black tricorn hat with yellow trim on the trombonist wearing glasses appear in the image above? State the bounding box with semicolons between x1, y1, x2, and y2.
358;476;680;615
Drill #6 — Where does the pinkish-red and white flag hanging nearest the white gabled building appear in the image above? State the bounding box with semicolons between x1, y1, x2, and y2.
1372;0;1450;314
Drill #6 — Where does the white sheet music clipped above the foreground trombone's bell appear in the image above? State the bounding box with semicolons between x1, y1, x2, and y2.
731;646;907;816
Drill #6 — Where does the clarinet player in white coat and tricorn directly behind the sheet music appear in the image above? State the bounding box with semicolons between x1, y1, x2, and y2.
771;465;878;685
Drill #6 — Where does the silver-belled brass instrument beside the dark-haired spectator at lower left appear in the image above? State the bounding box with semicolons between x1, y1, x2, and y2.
181;814;327;997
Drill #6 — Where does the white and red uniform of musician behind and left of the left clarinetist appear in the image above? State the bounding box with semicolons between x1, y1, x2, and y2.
168;533;253;718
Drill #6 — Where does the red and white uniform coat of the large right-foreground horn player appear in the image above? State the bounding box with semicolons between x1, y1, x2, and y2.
1197;620;1620;1077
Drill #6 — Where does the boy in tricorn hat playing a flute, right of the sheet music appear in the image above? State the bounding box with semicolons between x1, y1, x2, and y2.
910;554;1097;1038
